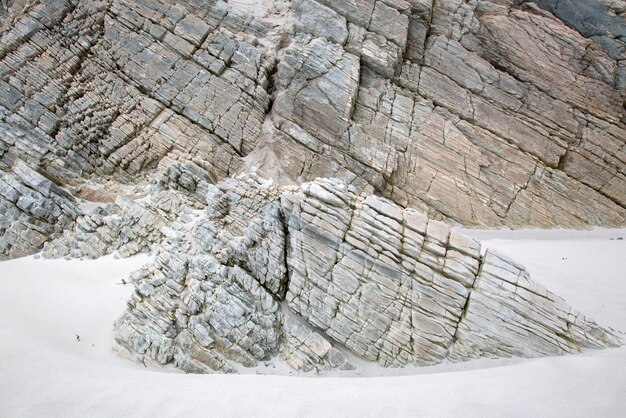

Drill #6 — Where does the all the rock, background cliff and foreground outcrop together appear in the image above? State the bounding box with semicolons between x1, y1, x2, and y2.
0;0;626;372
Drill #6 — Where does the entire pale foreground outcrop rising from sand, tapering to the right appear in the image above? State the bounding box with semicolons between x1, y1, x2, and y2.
107;175;621;372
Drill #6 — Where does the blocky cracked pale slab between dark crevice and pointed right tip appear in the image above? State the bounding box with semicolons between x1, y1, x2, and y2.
283;181;479;366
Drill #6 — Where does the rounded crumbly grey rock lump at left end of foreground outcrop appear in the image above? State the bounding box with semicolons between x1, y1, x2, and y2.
115;224;281;373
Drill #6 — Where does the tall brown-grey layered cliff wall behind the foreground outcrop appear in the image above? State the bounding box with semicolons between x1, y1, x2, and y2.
0;0;626;247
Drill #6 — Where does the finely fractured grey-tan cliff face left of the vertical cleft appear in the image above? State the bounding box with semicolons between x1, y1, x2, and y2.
0;0;274;185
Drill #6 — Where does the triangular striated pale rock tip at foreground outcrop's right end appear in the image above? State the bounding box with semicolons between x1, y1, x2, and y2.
451;251;620;359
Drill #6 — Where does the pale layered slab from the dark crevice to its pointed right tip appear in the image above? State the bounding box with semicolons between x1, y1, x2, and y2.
282;176;619;366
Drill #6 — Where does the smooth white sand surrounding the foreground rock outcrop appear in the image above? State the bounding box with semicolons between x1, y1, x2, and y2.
0;229;626;417
